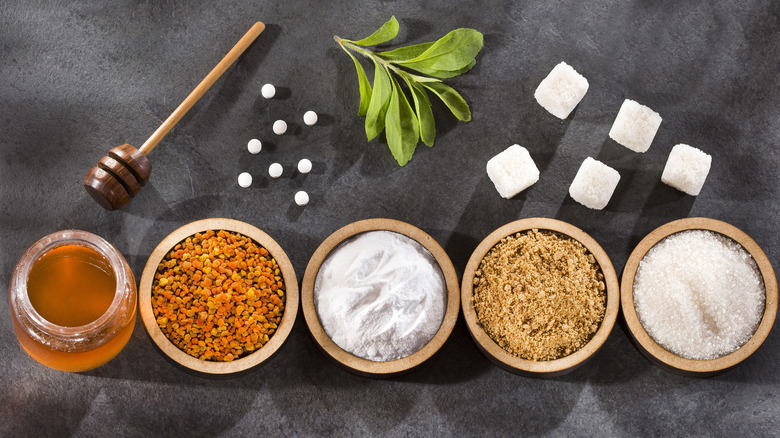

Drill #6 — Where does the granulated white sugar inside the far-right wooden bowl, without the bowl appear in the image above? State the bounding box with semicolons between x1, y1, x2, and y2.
634;230;766;360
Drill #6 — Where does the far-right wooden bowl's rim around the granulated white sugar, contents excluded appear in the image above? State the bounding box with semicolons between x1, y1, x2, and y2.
620;217;777;377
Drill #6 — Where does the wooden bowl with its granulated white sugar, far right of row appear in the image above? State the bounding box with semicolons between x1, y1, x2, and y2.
621;218;777;377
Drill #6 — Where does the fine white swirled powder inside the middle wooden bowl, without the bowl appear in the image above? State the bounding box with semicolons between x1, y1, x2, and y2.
314;231;447;362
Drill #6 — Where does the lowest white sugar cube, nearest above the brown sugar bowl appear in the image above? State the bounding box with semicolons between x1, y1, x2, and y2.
569;157;620;210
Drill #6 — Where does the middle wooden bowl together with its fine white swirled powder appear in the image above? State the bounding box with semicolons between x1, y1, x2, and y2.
301;219;460;378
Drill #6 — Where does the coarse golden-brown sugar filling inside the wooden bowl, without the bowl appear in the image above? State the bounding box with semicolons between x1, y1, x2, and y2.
474;229;606;361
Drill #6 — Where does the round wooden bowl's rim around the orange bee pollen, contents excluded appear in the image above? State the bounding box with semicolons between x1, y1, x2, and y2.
138;218;299;375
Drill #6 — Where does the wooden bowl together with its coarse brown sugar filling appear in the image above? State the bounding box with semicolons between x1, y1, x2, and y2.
461;218;620;377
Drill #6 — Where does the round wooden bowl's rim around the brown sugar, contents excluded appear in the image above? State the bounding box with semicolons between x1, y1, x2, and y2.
461;218;620;377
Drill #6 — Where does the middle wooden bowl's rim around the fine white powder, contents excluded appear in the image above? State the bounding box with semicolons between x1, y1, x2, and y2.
301;219;460;378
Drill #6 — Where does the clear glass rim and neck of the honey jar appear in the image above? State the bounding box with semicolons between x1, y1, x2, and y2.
9;230;128;341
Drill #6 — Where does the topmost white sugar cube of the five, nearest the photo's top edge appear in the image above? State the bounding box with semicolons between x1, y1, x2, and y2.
534;62;588;119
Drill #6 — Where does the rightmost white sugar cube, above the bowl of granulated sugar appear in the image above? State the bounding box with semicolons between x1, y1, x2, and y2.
661;144;712;196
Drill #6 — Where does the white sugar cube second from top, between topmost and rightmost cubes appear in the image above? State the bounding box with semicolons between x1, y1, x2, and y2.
609;99;661;152
